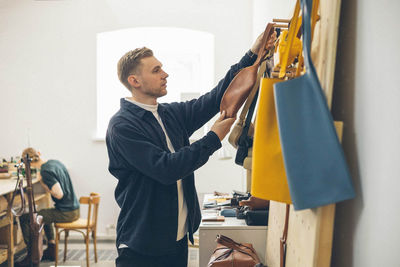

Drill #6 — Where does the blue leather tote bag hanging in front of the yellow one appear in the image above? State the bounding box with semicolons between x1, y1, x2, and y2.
274;0;355;210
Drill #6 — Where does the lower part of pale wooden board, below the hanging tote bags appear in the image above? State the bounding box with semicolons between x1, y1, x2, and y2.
265;122;343;267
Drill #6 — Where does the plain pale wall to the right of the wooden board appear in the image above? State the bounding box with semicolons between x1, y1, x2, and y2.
332;0;400;267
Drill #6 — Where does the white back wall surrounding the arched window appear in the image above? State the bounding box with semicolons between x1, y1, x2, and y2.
0;0;253;233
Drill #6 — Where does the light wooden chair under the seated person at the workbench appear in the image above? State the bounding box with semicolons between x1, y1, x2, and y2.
54;193;100;267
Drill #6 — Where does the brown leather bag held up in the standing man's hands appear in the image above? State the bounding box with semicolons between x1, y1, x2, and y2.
220;23;274;118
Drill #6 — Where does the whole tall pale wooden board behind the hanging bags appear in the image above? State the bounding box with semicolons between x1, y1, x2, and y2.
266;0;343;267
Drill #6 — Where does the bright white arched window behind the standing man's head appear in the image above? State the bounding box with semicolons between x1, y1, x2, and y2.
95;27;214;140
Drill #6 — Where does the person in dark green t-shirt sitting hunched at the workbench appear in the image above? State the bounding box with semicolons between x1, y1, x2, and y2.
16;148;79;266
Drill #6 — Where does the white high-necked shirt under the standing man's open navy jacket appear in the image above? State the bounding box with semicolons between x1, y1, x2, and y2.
124;98;188;242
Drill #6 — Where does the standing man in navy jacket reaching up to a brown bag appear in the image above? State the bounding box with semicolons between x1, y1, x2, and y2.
106;32;274;267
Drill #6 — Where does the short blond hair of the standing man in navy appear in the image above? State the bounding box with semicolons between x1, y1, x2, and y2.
117;47;153;91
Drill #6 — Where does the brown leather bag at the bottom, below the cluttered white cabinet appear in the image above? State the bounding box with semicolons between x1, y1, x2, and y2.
207;235;260;267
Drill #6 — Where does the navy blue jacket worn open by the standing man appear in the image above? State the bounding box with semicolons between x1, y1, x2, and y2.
106;50;254;255
